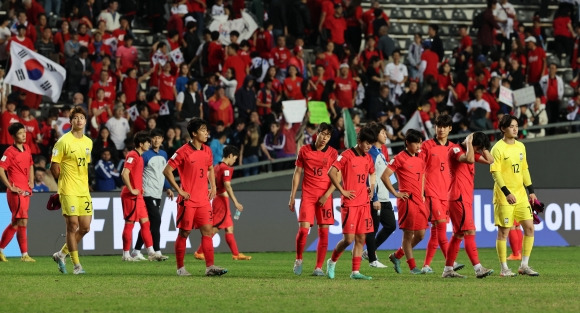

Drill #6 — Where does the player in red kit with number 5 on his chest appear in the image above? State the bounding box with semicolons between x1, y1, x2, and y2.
419;114;464;274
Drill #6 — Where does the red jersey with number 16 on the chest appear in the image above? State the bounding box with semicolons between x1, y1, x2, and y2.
296;142;338;199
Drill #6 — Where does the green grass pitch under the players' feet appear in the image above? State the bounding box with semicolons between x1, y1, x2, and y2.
0;247;580;313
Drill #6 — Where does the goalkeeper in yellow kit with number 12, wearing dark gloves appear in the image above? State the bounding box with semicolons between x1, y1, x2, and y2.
490;115;539;277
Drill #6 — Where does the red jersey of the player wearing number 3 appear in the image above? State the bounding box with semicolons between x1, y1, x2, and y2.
167;142;213;207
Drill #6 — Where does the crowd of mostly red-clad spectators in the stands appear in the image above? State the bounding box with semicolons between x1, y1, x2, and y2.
0;0;580;190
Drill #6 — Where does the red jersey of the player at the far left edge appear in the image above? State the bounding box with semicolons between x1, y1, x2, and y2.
0;144;34;192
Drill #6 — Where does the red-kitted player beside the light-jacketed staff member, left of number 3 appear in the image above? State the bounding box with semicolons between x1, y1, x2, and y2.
121;131;166;262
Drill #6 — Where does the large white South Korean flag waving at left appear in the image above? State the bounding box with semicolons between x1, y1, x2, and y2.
4;41;66;102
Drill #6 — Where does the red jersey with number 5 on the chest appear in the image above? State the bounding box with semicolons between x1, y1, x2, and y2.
415;138;453;200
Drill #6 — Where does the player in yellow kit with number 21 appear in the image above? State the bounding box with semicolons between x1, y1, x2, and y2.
50;106;93;275
